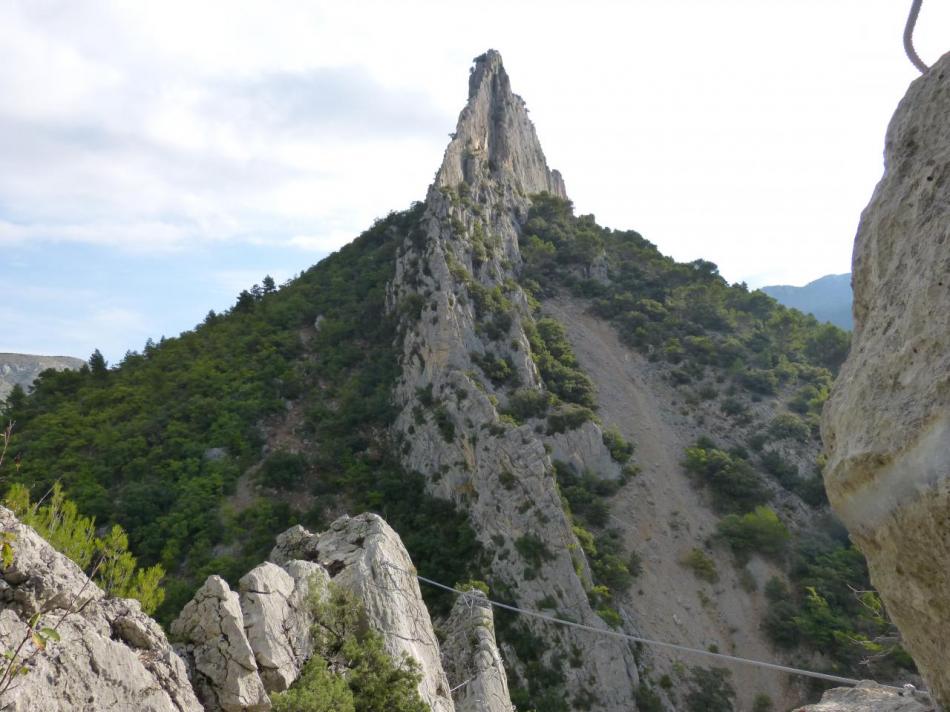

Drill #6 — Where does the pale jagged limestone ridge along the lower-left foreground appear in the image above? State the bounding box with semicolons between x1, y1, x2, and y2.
0;500;513;712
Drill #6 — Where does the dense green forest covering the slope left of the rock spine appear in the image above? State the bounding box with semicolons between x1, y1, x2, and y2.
3;204;479;622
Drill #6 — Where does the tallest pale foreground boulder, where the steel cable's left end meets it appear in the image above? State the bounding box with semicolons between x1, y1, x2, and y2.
270;514;454;712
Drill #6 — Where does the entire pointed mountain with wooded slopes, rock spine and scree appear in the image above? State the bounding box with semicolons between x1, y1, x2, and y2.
3;52;924;712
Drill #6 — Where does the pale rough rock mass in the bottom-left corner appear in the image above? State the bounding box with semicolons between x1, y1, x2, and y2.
0;507;202;712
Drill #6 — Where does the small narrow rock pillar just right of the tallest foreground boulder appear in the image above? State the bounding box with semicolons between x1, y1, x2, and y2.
442;589;514;712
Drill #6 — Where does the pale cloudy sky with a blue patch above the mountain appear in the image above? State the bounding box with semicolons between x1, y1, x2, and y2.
0;0;950;362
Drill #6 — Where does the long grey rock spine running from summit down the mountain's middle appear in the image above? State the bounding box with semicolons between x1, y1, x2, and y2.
389;51;638;712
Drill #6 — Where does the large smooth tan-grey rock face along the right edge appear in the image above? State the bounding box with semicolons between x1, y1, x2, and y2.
823;55;950;706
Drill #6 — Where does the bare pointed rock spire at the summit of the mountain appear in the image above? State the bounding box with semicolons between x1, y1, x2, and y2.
435;49;567;198
